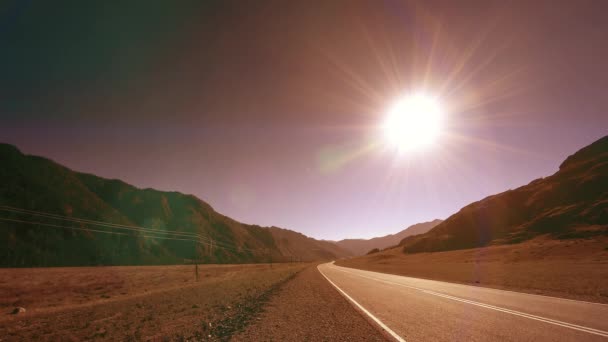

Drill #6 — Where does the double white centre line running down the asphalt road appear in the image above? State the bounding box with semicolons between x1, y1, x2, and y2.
336;268;608;337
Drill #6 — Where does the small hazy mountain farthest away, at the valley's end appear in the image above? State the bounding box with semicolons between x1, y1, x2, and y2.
334;219;442;255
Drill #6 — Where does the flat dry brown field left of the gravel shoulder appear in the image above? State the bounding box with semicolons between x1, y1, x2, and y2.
0;264;307;341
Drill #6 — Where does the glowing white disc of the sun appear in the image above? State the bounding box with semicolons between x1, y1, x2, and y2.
383;94;442;151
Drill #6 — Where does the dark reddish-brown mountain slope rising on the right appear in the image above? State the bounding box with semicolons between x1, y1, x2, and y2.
400;136;608;253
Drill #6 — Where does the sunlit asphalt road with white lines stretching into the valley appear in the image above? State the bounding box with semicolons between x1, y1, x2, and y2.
318;263;608;341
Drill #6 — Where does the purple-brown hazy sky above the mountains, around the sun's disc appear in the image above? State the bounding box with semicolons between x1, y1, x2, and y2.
0;0;608;240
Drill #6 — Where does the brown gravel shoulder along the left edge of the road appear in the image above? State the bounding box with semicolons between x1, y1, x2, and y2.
232;267;385;342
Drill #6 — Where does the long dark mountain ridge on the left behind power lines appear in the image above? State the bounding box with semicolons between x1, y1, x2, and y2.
0;144;350;266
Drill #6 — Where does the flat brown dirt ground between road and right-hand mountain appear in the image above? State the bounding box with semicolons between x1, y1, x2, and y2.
336;238;608;303
